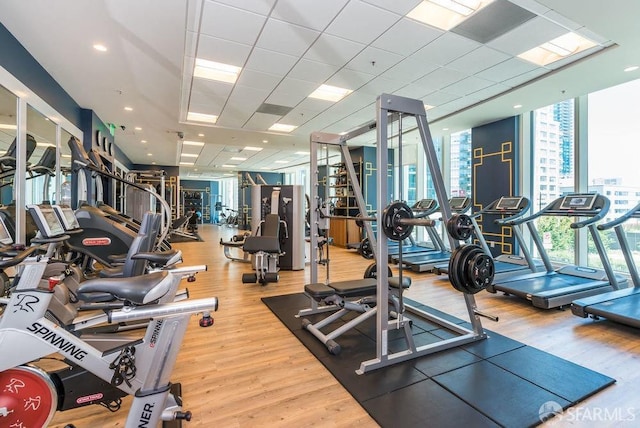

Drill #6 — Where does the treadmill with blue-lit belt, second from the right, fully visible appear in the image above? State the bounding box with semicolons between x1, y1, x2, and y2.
486;193;628;309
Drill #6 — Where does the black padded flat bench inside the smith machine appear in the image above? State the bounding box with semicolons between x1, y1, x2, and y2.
302;277;411;355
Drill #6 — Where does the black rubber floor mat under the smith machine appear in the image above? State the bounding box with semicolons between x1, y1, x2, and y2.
262;293;615;428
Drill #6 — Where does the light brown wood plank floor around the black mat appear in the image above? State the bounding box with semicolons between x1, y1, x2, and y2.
51;225;640;428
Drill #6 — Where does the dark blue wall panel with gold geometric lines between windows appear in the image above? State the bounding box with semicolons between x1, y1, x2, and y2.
471;117;520;256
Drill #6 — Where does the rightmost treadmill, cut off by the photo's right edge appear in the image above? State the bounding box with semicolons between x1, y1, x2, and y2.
571;203;640;328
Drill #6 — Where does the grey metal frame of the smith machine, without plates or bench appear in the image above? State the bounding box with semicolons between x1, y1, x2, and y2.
301;94;487;374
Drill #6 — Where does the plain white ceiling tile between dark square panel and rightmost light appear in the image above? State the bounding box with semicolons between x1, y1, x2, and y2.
487;17;567;56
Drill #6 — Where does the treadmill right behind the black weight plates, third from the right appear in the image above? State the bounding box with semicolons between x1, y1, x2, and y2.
434;196;544;282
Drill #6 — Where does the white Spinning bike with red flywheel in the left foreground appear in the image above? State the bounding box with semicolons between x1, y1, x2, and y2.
0;247;218;428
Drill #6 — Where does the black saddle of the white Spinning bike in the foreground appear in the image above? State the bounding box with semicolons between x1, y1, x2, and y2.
77;271;172;305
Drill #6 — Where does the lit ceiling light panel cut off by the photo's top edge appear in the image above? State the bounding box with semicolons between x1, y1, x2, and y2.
407;0;493;31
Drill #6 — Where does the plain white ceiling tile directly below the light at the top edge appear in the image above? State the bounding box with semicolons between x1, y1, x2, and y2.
372;17;444;56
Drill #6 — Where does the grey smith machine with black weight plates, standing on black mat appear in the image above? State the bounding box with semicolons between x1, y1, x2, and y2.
299;94;498;374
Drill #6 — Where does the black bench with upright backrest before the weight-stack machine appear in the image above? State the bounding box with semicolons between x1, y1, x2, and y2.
242;214;284;285
